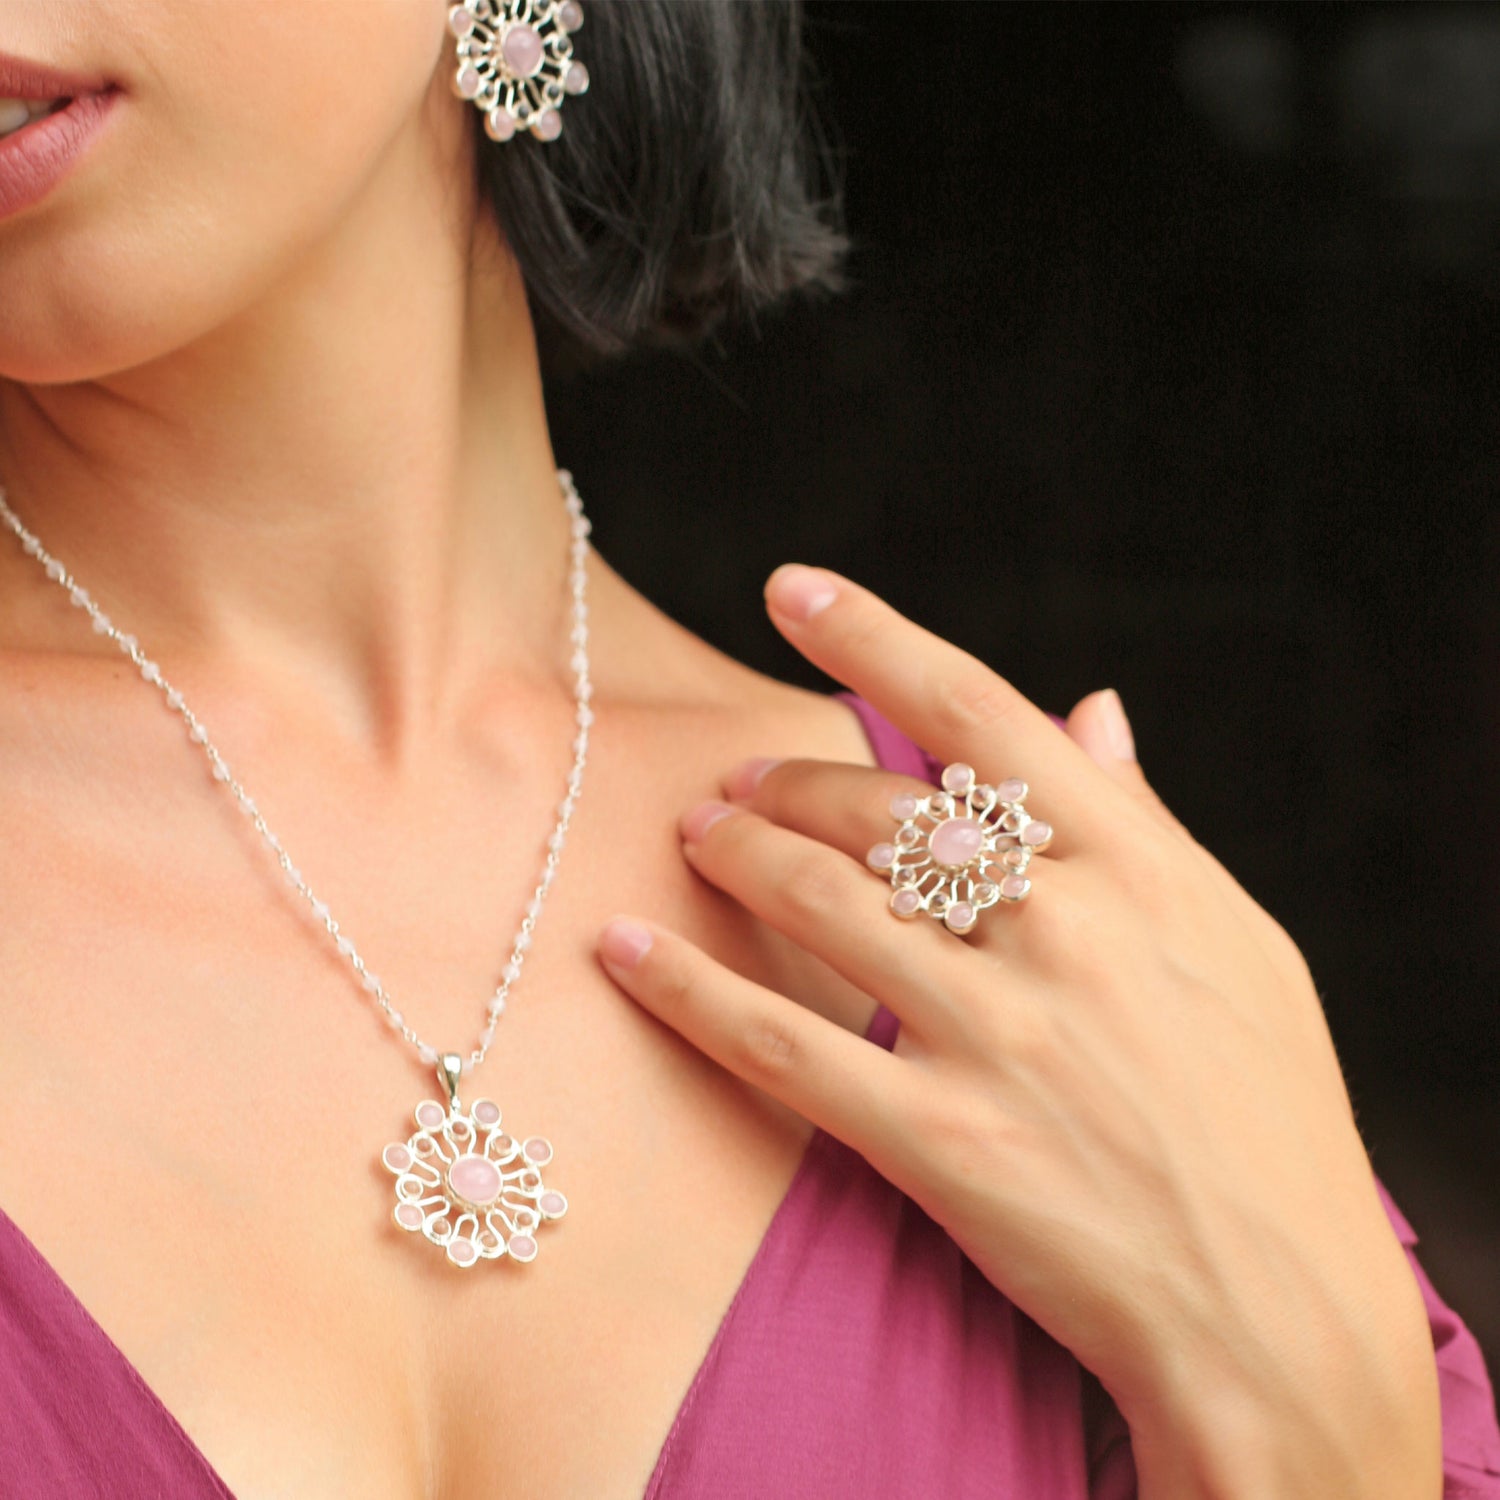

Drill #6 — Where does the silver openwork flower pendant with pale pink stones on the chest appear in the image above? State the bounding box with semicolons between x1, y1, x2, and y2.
380;1052;567;1266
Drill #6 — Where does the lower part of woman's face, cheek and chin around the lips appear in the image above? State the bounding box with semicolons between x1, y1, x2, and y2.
0;0;471;383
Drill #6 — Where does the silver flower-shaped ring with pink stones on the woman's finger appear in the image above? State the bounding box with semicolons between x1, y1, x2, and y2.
866;761;1052;936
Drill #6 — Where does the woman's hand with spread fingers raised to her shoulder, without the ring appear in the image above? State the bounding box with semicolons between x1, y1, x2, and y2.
600;567;1442;1497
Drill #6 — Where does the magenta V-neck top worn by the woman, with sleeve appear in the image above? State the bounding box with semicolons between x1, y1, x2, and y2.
0;695;1500;1500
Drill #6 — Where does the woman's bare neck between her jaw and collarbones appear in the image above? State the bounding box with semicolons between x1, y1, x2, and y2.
0;109;567;756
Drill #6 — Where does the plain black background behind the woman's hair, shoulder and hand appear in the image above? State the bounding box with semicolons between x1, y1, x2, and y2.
551;0;1500;1371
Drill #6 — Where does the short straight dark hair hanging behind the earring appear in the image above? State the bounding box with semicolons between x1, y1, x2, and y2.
473;0;848;368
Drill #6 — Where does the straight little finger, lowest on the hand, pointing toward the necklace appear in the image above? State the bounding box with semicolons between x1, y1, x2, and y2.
599;918;912;1176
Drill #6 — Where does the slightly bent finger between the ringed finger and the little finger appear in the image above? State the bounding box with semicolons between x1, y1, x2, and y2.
683;803;974;1040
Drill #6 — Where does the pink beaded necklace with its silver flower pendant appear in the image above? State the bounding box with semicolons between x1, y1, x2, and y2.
0;470;594;1266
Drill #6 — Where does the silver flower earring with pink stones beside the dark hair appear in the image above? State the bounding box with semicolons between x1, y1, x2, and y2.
449;0;588;141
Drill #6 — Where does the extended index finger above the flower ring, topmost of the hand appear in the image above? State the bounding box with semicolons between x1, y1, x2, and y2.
767;564;1119;840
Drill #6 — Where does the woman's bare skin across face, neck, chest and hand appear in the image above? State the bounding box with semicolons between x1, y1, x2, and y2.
0;0;1437;1500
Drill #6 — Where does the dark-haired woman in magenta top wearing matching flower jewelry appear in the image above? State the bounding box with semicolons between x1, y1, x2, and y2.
0;0;1500;1500
